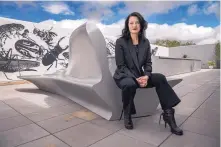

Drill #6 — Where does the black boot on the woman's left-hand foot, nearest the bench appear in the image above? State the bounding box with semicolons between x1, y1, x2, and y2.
124;106;133;130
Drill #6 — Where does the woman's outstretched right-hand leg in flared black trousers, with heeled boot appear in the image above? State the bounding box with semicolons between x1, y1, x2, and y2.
148;73;183;135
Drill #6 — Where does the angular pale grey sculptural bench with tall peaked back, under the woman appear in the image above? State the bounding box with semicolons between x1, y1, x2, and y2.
18;22;181;120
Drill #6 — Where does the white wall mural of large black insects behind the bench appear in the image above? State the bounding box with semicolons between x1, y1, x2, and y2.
0;22;115;80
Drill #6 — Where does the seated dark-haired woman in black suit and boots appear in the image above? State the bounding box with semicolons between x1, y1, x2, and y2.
113;12;183;135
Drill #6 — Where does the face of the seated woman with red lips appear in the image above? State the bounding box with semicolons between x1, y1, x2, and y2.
128;16;140;34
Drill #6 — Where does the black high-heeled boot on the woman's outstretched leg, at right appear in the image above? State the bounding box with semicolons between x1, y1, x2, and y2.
160;108;183;135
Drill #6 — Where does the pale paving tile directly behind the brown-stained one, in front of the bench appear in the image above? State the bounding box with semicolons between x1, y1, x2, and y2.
25;103;83;122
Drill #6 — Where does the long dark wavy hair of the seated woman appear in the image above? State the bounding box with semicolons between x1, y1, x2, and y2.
121;12;147;40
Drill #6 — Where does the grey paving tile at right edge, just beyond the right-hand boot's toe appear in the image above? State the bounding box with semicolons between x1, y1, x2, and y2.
182;117;220;139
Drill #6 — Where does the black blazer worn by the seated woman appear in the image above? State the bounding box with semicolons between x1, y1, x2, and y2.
113;37;152;83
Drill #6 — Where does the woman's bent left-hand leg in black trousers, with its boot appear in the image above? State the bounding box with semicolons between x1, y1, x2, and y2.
115;78;138;129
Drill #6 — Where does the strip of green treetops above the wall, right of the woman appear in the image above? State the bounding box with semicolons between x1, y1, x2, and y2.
154;40;196;47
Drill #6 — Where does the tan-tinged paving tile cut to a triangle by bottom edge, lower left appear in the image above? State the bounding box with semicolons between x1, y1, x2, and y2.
18;135;69;147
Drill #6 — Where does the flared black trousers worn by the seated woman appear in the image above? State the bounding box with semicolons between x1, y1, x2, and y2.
118;73;180;110
